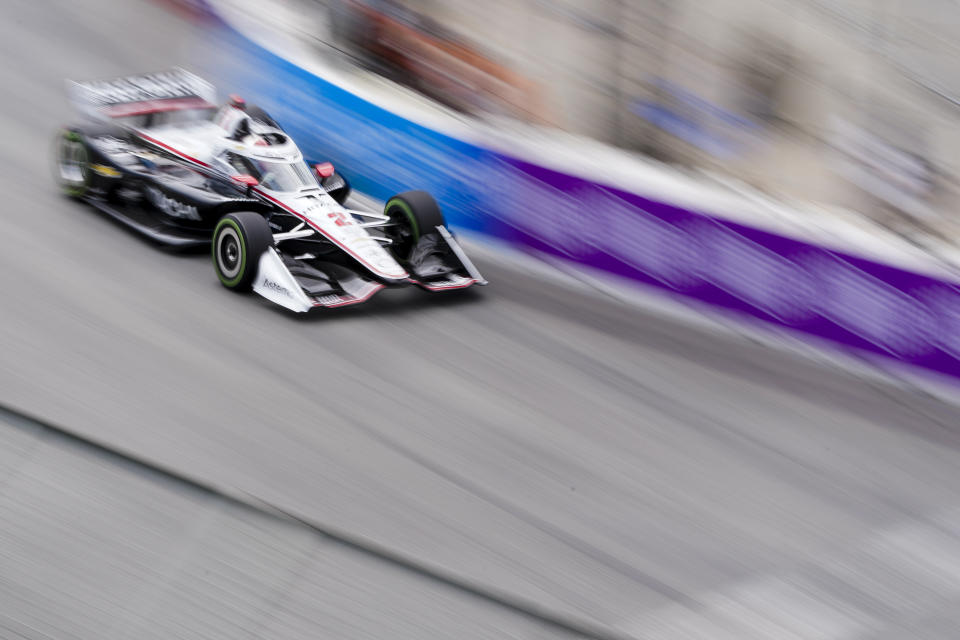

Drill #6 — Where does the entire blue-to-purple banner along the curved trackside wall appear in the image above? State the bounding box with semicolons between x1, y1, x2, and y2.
199;6;960;378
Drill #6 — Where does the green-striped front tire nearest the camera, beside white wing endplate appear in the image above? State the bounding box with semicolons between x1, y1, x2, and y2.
210;211;273;291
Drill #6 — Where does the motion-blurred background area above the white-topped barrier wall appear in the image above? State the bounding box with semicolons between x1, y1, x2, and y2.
288;0;960;241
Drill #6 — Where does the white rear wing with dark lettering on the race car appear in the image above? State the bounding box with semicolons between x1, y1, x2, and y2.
67;68;217;120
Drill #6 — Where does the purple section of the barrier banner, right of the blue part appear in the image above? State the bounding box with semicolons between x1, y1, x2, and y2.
486;159;960;377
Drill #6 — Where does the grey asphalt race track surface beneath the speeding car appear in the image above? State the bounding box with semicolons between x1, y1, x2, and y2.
0;0;960;638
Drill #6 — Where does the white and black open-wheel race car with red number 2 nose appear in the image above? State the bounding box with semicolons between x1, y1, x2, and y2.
55;69;487;312
